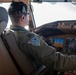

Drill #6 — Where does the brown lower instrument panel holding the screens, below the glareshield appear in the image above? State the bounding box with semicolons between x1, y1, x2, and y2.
45;35;76;53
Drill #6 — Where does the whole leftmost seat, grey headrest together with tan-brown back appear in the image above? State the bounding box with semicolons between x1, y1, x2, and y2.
0;7;20;75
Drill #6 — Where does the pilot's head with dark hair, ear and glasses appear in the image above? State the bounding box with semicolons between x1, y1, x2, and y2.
8;1;29;26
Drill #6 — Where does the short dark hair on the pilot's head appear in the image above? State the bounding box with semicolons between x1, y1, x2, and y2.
8;1;27;22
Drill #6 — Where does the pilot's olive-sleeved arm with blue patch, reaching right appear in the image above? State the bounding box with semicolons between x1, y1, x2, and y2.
24;34;76;71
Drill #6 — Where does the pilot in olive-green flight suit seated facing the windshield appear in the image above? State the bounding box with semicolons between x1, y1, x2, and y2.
8;1;76;74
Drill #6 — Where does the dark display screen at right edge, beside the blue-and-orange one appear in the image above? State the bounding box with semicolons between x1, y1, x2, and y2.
65;38;76;53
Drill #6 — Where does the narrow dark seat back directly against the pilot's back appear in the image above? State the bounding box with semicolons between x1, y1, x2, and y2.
3;30;35;75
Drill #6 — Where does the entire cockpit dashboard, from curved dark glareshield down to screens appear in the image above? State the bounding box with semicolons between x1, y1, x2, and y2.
36;21;76;75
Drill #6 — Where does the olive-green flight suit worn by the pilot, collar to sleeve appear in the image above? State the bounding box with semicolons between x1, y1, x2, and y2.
10;25;76;71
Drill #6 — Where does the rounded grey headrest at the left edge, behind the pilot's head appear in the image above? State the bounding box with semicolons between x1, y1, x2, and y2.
0;7;8;33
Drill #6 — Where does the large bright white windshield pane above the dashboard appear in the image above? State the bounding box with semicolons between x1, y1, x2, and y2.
31;2;76;27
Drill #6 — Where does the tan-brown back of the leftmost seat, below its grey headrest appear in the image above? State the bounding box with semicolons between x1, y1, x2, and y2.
0;36;20;75
